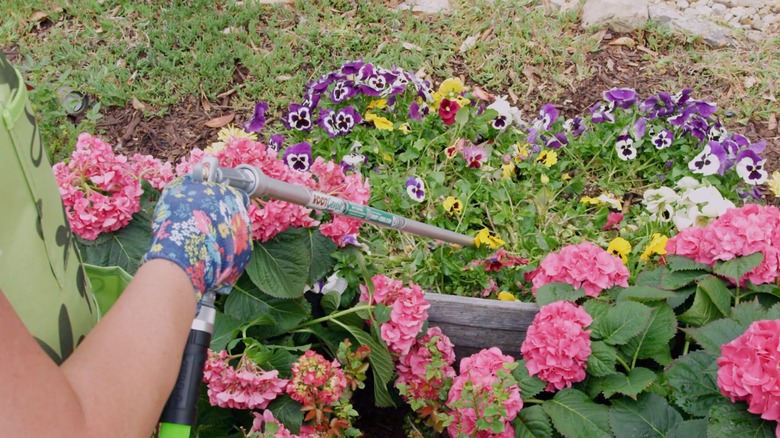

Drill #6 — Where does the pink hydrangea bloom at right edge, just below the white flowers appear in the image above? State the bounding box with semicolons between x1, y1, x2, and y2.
666;204;780;284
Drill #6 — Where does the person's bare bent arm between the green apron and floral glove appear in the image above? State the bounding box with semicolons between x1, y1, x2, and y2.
0;259;196;438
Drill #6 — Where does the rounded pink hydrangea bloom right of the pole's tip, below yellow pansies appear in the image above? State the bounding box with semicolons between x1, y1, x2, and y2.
532;242;629;297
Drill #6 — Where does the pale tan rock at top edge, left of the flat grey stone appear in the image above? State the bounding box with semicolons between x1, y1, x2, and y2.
582;0;648;32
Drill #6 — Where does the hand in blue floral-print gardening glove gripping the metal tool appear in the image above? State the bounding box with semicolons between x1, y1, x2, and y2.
143;175;252;301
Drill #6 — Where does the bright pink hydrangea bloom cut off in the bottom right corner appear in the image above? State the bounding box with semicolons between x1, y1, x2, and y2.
718;320;780;436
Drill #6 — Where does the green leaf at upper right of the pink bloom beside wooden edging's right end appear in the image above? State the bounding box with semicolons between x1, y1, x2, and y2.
590;301;652;345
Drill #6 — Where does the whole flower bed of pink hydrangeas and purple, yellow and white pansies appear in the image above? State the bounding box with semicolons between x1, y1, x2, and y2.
55;62;780;437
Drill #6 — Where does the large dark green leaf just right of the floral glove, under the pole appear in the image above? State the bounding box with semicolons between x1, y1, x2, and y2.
246;228;312;298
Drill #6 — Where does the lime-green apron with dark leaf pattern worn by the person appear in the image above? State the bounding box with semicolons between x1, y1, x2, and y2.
0;52;99;363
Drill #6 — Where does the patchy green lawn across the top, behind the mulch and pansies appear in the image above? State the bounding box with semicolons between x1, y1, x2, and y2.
0;0;780;157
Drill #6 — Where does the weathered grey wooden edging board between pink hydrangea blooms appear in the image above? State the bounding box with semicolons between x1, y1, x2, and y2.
425;293;539;359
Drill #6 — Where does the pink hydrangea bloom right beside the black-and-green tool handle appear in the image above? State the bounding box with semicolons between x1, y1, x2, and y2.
203;350;287;409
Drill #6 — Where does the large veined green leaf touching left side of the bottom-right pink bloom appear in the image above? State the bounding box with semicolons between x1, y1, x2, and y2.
666;350;723;417
